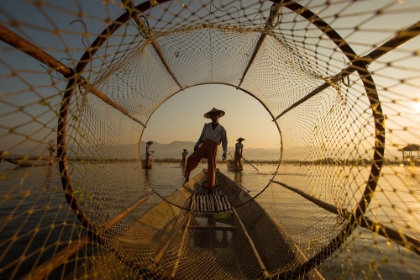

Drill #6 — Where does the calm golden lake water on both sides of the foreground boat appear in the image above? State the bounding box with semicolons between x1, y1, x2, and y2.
0;162;420;279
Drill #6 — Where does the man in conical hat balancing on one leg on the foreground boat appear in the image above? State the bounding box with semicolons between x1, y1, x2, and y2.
184;108;227;190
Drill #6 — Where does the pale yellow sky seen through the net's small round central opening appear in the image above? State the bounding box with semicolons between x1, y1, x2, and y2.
142;85;280;149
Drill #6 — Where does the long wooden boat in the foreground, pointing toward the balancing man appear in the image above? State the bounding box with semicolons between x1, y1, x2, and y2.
68;170;323;279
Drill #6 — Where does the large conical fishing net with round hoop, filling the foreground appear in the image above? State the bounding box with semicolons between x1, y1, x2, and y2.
0;0;420;279
